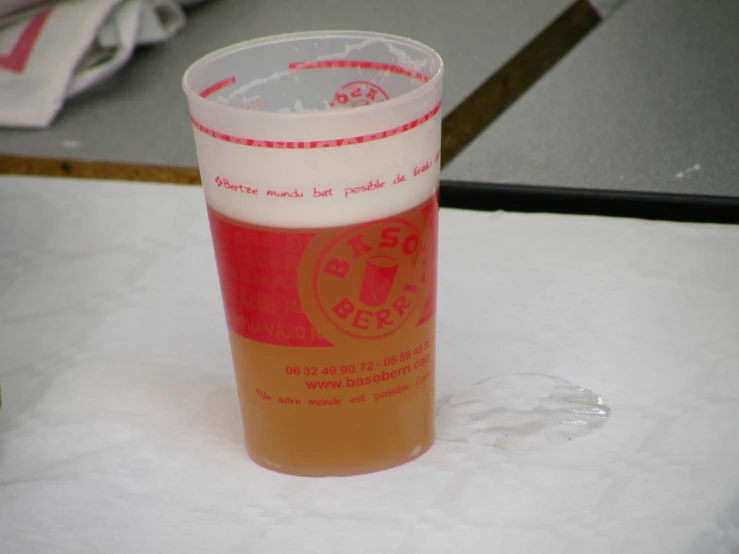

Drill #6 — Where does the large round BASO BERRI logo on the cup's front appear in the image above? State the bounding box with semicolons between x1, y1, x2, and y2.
313;219;426;339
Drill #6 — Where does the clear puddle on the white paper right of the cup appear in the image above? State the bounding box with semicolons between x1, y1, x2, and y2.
436;374;611;450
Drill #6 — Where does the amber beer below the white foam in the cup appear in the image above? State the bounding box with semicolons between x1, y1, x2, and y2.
209;192;438;476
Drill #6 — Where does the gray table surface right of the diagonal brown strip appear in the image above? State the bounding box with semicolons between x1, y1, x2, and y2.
444;0;739;197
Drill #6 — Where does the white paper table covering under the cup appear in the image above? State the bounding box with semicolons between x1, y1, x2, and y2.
0;177;739;554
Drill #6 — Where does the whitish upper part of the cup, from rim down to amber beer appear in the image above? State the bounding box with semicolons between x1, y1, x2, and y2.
183;32;443;228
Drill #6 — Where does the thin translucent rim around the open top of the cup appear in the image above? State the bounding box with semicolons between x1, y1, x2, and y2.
181;31;444;120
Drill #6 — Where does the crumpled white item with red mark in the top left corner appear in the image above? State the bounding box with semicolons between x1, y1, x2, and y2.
0;0;205;127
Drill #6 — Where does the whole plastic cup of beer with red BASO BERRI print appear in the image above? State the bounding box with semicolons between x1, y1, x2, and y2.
183;31;443;476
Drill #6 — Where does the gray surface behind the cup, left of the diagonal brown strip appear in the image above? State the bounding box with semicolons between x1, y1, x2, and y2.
0;0;570;166
